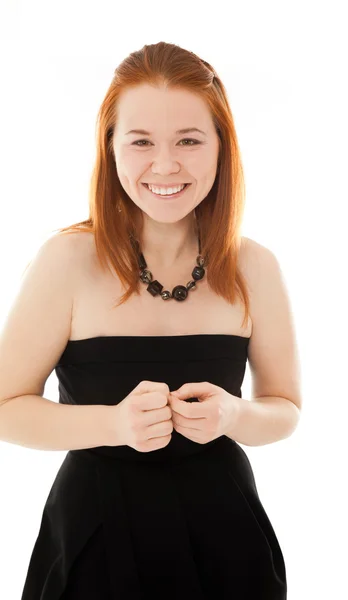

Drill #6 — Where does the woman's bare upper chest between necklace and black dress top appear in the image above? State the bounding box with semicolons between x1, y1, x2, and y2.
70;234;252;340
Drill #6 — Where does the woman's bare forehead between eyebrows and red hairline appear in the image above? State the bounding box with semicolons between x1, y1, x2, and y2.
117;84;212;133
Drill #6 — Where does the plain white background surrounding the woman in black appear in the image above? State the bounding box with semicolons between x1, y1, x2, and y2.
0;0;348;600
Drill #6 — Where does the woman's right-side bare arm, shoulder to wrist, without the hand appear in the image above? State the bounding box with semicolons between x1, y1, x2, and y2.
231;238;302;446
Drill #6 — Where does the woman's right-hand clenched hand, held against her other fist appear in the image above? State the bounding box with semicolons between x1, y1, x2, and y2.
169;381;241;444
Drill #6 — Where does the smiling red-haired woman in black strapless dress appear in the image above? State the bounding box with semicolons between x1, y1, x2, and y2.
1;42;301;600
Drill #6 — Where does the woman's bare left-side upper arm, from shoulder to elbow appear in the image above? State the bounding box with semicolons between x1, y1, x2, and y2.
0;233;87;405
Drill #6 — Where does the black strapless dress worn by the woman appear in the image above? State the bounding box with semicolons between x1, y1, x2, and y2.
21;334;287;600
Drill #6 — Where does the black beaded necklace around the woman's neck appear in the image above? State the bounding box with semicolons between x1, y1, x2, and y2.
130;234;205;302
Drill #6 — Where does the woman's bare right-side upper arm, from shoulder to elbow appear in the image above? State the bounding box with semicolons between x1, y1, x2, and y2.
240;238;302;408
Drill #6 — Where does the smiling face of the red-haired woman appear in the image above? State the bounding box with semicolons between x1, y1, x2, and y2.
113;84;219;223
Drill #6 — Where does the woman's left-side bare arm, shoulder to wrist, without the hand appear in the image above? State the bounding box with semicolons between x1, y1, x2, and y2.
0;234;118;450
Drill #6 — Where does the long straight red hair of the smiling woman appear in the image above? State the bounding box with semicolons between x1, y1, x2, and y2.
51;42;250;327
